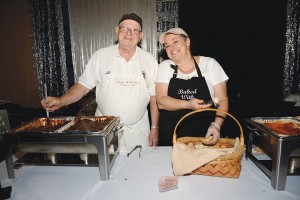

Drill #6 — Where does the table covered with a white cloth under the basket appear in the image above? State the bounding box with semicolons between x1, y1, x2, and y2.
0;147;300;200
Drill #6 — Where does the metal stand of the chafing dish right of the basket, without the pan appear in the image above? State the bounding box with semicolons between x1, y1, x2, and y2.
246;119;300;190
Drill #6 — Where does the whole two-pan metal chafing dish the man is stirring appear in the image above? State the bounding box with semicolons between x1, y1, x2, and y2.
4;116;120;180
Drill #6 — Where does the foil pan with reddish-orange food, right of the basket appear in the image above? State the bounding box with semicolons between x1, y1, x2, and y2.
251;117;300;137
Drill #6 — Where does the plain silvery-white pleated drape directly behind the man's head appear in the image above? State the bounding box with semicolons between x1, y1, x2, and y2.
68;0;157;80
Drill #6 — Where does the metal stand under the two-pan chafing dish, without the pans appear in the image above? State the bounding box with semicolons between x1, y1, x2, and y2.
3;126;119;180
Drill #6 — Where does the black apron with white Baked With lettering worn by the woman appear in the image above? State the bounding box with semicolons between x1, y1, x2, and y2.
158;60;215;146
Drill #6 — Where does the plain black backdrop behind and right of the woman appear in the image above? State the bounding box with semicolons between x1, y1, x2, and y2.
179;0;289;116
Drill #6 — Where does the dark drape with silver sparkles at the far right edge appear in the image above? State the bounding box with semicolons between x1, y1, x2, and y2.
283;0;300;96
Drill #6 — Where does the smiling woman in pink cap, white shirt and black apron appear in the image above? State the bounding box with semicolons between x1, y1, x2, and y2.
156;28;228;146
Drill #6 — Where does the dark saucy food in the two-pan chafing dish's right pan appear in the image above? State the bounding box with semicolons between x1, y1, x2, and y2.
66;116;115;132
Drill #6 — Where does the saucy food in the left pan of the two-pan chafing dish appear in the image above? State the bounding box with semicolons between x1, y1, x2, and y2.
14;117;74;133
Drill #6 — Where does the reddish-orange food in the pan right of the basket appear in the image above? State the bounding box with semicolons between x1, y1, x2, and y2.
256;118;300;136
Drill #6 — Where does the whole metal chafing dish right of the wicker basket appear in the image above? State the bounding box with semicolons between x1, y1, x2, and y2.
246;117;300;190
